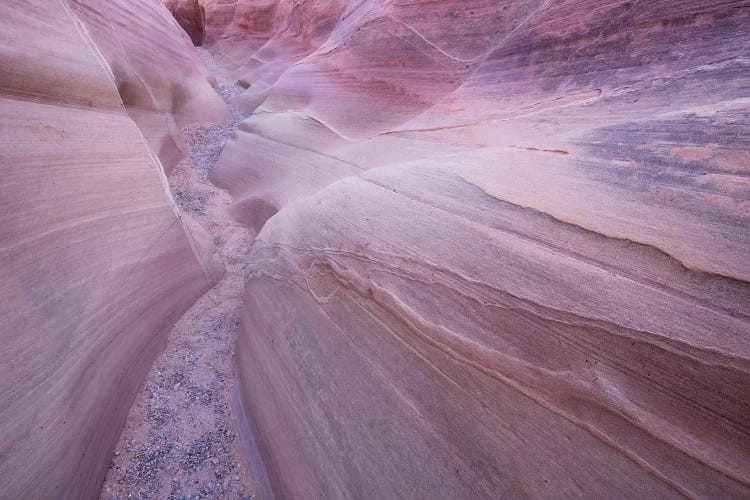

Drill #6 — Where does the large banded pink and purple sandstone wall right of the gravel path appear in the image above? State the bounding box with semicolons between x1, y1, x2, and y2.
200;0;750;498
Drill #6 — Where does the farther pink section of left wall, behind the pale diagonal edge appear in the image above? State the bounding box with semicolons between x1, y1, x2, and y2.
68;0;231;174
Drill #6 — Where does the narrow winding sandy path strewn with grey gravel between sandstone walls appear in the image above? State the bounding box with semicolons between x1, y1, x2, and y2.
101;49;255;500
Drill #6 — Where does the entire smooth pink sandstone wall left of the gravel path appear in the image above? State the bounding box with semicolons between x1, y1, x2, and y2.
0;0;226;499
